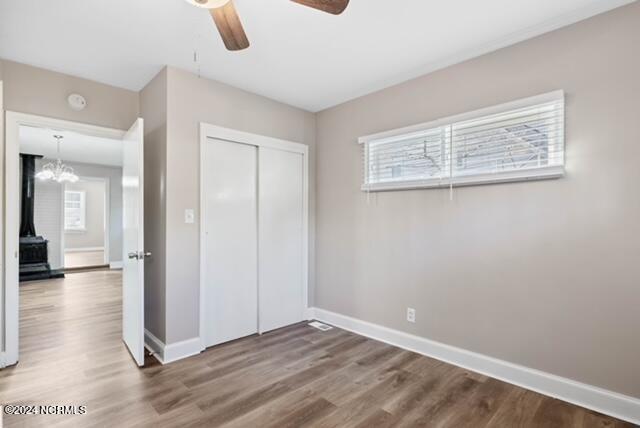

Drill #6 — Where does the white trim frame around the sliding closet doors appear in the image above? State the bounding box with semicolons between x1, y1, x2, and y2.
198;122;309;350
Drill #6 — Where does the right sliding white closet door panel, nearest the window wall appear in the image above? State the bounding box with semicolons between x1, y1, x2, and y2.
258;147;304;333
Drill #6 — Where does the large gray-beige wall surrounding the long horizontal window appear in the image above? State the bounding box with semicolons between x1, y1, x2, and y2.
315;3;640;397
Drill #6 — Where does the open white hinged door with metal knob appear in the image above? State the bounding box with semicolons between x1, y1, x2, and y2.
122;119;147;366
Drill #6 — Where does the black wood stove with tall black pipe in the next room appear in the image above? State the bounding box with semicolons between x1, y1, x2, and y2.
20;154;64;281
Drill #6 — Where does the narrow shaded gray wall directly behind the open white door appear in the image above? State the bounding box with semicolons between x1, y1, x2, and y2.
140;69;167;341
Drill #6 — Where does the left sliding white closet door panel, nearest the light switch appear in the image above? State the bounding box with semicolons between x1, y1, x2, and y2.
201;139;258;346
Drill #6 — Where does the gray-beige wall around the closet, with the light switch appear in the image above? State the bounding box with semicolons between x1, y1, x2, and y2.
166;68;316;343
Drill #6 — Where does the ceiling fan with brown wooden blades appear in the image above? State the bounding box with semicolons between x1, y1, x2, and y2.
186;0;349;51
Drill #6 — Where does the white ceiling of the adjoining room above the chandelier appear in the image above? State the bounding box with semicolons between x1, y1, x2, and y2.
19;126;122;166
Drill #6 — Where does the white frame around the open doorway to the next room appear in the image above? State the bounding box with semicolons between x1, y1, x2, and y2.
0;111;126;367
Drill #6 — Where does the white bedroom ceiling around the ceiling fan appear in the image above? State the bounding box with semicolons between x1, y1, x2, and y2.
0;0;633;111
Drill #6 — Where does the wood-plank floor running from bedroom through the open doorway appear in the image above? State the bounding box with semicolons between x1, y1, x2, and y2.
0;271;630;428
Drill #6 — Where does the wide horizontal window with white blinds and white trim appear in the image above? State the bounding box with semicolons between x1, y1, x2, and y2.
360;91;564;191
